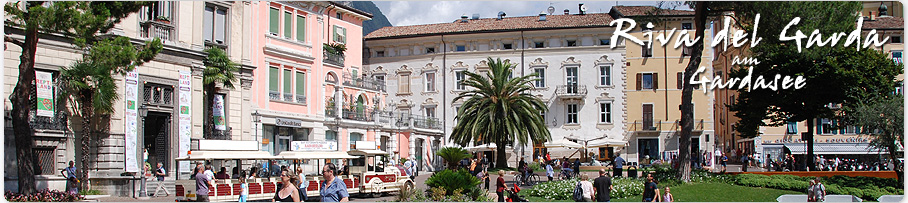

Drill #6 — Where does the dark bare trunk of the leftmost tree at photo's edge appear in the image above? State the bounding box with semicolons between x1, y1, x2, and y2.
10;21;38;194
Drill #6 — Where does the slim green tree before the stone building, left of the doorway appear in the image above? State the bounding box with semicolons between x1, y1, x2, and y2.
60;37;163;188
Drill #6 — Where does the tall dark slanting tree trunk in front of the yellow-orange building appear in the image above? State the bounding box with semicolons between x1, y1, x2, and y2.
677;1;709;182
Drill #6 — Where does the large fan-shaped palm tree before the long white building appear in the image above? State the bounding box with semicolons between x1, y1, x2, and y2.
451;57;552;167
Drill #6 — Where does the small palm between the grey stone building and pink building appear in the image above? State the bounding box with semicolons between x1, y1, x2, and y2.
202;47;239;138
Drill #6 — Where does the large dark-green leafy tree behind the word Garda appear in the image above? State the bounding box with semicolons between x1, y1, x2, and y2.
729;2;901;169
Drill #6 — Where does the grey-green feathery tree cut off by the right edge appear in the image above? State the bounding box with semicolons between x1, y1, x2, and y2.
847;94;905;182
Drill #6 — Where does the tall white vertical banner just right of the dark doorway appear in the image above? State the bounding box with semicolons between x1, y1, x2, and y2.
178;71;192;173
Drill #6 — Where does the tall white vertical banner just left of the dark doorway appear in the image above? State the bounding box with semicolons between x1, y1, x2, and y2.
124;70;139;172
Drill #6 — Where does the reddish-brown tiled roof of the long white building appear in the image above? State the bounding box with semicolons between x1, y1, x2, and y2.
364;13;614;40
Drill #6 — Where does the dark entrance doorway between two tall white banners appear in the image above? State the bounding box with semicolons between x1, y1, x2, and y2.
143;111;171;169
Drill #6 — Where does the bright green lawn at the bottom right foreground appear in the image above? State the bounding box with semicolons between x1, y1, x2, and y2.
612;183;804;202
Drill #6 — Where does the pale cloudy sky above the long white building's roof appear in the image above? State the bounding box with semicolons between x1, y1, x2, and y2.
373;1;676;26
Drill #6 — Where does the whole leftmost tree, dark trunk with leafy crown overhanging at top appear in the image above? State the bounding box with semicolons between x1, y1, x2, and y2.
3;1;151;194
